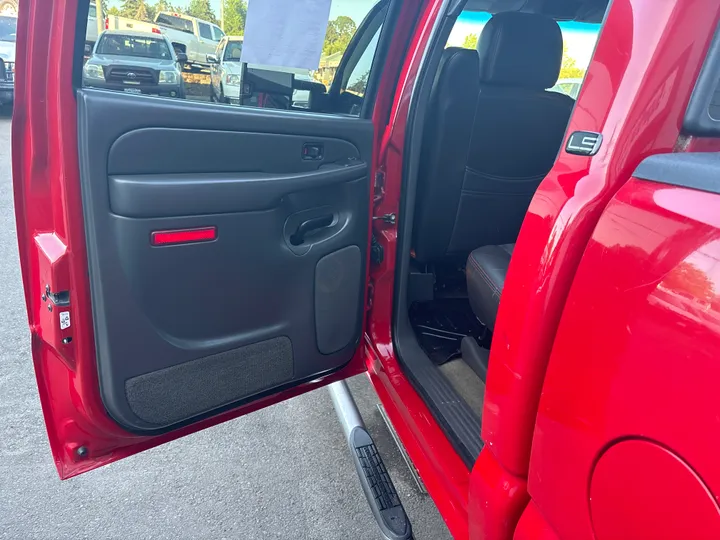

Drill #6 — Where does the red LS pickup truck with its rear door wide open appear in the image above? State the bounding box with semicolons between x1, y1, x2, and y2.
12;0;720;540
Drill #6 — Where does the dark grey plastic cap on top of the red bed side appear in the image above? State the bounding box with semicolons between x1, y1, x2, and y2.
633;152;720;194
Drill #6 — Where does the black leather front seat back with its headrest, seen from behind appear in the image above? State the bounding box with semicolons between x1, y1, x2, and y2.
413;12;575;262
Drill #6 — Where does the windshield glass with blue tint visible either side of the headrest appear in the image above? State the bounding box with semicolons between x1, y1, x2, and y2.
447;11;600;98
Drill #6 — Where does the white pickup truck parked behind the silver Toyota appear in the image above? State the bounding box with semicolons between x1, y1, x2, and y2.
105;11;225;66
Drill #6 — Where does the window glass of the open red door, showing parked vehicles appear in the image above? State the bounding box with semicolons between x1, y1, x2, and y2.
79;0;389;115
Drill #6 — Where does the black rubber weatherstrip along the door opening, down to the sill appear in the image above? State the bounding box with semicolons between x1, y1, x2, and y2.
393;0;483;468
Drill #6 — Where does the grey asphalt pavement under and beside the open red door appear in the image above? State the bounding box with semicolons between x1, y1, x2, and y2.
0;115;450;540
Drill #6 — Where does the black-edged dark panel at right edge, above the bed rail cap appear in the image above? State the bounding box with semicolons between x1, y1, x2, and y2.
683;22;720;137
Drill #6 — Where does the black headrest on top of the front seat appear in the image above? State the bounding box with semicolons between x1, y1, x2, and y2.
477;11;563;89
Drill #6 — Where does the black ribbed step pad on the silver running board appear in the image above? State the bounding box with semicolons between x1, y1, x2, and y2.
348;427;412;540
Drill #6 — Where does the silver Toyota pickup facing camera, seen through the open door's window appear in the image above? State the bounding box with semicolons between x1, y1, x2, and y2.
83;30;185;98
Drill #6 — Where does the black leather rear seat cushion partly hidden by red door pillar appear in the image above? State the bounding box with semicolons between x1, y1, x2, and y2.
465;244;515;330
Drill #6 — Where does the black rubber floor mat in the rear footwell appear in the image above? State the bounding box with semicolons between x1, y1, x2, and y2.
410;298;490;365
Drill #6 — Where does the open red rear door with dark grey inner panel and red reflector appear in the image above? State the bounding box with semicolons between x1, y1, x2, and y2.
13;0;389;478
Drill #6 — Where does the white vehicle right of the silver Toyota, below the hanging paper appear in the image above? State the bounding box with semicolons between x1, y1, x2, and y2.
207;36;314;108
